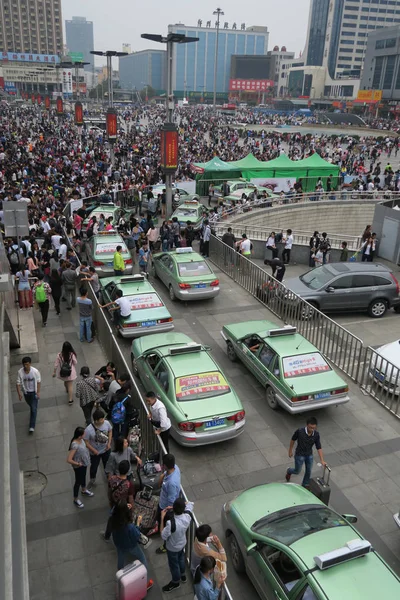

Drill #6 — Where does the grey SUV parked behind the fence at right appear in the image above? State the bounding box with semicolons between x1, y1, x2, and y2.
285;262;400;318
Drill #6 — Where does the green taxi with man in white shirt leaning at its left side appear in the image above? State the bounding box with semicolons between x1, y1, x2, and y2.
100;275;174;338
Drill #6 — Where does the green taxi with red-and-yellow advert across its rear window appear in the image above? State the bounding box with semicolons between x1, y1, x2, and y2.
131;333;245;446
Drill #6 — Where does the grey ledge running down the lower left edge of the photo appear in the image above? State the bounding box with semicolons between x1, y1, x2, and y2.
0;296;29;600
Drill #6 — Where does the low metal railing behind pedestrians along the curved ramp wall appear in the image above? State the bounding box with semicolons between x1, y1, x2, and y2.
214;222;361;251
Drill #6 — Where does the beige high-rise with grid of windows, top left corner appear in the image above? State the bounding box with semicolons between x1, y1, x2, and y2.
0;0;63;55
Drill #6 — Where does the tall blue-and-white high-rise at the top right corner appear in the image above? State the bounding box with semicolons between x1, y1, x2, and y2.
304;0;400;79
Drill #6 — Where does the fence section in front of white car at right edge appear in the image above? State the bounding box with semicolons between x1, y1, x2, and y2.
360;346;400;418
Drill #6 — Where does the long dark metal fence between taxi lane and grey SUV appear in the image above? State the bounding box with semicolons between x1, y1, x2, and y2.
210;236;364;381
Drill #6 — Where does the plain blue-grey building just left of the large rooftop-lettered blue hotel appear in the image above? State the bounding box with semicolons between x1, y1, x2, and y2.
119;50;167;91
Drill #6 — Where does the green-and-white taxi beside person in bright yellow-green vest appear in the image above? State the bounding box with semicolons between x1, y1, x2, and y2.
85;231;133;277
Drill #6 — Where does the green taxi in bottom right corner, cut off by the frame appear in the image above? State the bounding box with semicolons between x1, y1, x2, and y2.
221;483;400;600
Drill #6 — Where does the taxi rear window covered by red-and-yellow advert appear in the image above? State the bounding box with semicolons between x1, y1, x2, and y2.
175;371;231;402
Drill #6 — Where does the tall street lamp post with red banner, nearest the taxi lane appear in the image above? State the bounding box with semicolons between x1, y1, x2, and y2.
141;33;199;217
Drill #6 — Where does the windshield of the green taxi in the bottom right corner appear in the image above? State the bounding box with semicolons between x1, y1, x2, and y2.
251;506;348;546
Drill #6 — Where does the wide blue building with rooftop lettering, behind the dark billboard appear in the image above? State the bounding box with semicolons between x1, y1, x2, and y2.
168;21;269;94
